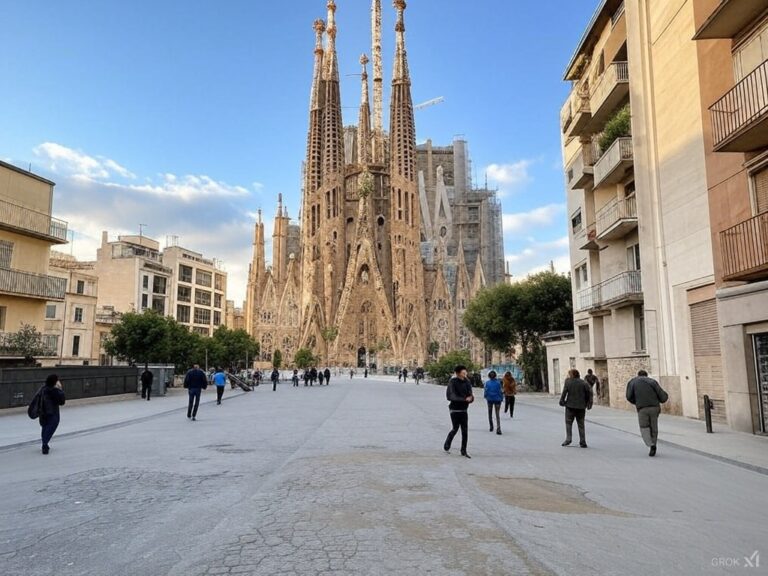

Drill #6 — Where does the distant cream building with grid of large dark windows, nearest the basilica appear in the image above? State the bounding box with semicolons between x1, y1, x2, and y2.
163;245;227;336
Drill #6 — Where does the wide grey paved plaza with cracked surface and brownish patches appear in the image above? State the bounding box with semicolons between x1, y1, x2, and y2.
0;377;768;576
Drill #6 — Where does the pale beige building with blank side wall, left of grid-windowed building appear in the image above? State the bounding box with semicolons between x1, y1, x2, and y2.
94;232;173;316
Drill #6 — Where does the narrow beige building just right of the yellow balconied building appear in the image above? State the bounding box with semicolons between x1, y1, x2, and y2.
43;251;99;365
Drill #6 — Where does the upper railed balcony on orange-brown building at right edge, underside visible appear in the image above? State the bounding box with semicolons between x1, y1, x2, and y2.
709;60;768;152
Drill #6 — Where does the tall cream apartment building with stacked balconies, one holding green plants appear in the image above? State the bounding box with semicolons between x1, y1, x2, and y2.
550;0;716;422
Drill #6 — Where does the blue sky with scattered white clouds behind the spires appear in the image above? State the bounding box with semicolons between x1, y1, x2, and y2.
0;0;598;304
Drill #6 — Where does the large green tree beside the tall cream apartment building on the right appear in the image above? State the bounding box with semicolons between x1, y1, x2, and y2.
464;272;573;390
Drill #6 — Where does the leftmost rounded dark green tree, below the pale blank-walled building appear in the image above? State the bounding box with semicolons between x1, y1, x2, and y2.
104;310;170;364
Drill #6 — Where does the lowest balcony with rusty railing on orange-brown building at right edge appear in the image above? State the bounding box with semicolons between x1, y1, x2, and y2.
720;212;768;281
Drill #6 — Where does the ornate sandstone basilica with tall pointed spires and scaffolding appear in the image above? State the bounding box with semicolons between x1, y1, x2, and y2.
245;0;503;367
